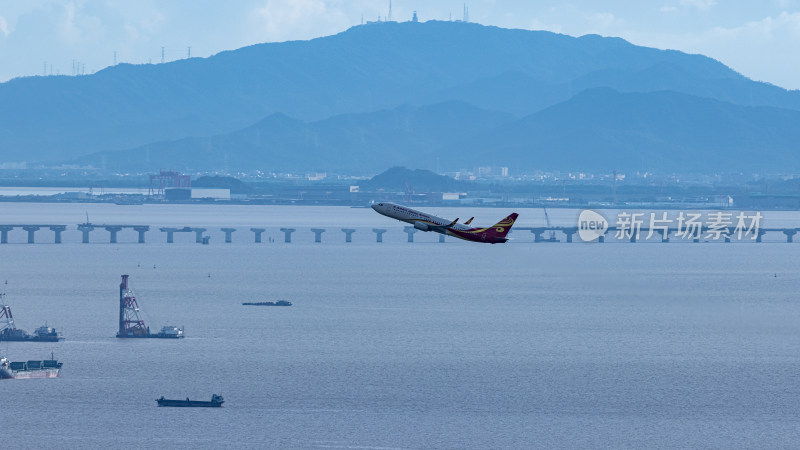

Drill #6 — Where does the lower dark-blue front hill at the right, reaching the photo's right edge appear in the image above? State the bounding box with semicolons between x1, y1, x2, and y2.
450;88;800;173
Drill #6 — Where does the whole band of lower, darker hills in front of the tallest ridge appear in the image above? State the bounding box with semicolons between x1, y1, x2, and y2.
73;88;800;175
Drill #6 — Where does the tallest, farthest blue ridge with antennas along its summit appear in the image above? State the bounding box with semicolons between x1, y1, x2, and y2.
0;21;800;168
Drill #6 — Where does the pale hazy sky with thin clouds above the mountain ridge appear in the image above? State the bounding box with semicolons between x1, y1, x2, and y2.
0;0;800;89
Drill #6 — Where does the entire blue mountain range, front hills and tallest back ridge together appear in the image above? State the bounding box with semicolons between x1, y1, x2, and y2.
0;21;800;174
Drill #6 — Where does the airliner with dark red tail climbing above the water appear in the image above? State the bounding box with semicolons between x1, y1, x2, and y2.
372;202;519;244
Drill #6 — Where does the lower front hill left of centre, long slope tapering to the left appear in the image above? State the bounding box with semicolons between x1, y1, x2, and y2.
71;102;514;175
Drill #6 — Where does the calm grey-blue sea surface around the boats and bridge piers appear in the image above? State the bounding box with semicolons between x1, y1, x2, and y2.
0;204;800;448
